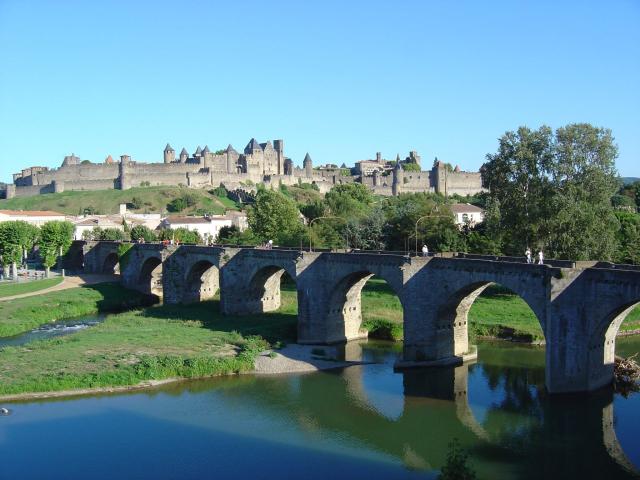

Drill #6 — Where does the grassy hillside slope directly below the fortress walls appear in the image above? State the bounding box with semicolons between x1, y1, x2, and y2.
0;186;237;215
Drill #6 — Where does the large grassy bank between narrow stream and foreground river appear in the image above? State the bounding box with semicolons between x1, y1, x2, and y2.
0;291;297;395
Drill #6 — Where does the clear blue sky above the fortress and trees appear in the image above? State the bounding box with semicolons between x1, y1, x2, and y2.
0;0;640;181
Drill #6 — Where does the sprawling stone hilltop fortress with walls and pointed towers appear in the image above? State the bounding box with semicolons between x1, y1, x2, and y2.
6;138;482;198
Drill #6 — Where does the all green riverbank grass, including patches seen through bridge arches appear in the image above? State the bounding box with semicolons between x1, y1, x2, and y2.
0;278;640;395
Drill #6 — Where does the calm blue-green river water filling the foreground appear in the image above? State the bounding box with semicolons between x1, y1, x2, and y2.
0;338;640;480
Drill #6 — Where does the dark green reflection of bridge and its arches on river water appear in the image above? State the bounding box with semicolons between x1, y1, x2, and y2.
211;346;635;478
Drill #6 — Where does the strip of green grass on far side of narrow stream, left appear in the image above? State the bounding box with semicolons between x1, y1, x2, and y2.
0;283;148;337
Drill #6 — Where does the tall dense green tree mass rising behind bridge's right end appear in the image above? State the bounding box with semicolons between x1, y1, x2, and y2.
482;123;619;259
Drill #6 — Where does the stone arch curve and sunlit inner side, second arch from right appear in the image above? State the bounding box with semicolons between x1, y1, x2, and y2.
436;280;544;357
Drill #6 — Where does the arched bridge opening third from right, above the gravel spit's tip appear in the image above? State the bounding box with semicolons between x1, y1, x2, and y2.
327;271;403;343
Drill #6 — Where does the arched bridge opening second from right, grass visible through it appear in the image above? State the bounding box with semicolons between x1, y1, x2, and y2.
436;281;544;358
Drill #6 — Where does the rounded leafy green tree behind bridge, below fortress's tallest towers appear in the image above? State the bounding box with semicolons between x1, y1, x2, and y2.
248;189;304;245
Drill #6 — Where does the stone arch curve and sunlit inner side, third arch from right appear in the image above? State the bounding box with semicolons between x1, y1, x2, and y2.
326;269;404;343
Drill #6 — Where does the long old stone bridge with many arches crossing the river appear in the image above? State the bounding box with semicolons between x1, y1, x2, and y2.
82;242;640;393
